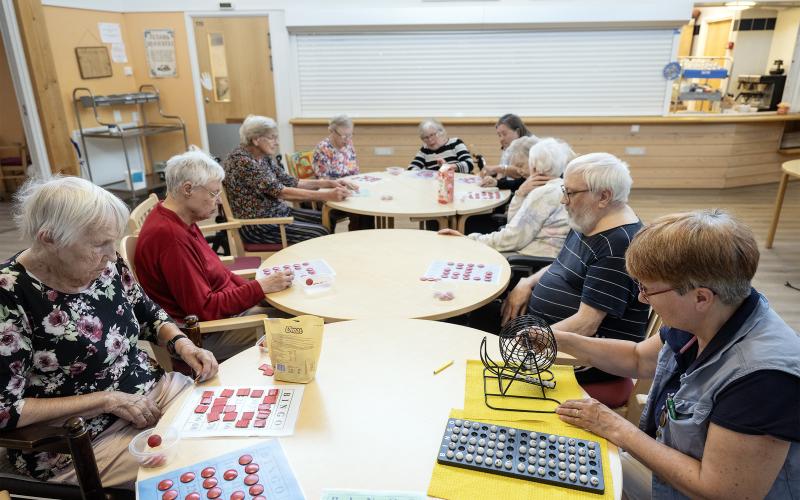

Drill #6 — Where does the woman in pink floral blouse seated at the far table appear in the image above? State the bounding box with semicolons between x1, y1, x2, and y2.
311;115;358;179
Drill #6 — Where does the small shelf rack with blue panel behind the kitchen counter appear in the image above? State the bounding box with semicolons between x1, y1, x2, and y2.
670;56;733;113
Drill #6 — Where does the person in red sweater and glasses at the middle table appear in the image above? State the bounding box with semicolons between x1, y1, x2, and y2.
134;146;293;360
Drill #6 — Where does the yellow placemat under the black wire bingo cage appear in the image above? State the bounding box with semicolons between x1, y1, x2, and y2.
464;360;584;422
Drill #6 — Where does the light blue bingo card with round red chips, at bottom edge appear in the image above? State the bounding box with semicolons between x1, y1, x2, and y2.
136;439;303;500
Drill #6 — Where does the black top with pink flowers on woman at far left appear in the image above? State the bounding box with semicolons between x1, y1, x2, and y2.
0;254;169;480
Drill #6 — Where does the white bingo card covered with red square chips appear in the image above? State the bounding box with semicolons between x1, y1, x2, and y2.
175;385;303;438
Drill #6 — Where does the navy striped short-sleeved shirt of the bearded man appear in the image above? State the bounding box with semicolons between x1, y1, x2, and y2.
528;222;650;382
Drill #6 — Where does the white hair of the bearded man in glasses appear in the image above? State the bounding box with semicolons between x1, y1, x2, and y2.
564;153;633;203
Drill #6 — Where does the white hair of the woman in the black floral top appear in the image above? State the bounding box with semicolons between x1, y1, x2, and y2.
14;176;130;248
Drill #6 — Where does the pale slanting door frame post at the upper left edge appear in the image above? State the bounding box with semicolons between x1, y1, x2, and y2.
0;0;52;179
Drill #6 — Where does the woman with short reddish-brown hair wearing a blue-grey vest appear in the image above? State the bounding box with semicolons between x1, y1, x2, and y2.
555;210;800;500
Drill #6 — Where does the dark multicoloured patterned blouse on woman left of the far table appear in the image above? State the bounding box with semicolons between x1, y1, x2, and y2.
222;146;298;219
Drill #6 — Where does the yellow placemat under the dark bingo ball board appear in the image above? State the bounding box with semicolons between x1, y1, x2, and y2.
428;409;614;500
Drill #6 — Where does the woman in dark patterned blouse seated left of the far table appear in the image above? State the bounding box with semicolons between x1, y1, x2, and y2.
223;115;358;243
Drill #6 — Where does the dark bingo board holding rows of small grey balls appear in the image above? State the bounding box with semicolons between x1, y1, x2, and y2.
437;418;605;494
